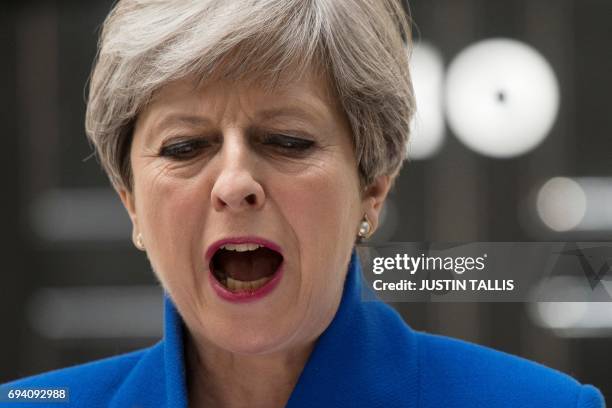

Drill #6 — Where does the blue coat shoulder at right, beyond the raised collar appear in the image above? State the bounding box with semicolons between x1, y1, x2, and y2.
417;333;604;408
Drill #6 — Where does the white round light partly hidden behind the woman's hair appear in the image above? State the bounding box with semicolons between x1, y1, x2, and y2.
408;42;444;159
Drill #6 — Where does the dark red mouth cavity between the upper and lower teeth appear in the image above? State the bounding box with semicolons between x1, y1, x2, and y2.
217;248;282;282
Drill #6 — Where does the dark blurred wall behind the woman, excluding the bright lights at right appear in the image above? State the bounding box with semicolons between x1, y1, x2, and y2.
0;0;612;399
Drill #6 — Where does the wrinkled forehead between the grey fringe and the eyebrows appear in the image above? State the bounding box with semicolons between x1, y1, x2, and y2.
137;70;342;142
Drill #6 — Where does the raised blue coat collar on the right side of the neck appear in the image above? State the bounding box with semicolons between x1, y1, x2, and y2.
287;251;418;408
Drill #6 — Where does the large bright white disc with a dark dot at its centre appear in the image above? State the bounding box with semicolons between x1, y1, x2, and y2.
446;39;559;158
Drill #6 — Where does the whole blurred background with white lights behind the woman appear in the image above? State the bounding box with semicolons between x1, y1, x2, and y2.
0;0;612;401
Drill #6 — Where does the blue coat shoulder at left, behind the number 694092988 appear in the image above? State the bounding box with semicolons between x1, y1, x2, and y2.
1;346;155;407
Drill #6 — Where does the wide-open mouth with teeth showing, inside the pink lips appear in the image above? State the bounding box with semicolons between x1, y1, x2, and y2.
210;243;283;293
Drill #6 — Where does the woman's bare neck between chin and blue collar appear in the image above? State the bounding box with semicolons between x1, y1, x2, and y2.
185;335;314;408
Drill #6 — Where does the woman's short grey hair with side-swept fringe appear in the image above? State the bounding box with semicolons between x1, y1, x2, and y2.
85;0;415;191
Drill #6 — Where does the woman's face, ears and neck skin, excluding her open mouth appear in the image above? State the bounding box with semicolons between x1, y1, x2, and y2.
119;71;390;407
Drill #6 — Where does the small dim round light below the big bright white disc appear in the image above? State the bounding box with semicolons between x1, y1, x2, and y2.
536;177;587;232
